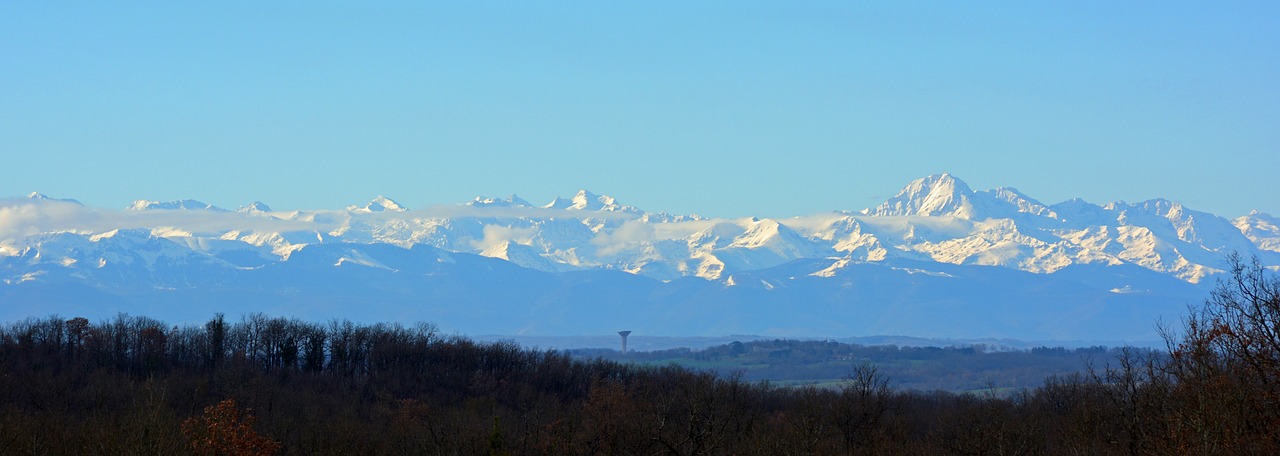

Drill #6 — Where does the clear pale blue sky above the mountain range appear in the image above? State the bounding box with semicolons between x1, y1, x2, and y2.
0;1;1280;216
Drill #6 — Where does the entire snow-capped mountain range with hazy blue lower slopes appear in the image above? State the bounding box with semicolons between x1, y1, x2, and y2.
0;174;1280;338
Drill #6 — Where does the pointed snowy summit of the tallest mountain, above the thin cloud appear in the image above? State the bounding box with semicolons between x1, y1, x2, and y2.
870;173;974;219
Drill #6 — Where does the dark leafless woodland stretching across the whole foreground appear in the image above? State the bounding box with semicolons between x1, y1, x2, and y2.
0;254;1280;455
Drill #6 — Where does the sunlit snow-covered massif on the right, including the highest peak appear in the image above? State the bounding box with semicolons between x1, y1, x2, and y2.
839;174;1280;283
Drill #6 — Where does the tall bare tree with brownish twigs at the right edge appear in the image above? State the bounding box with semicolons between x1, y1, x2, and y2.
1166;255;1280;453
